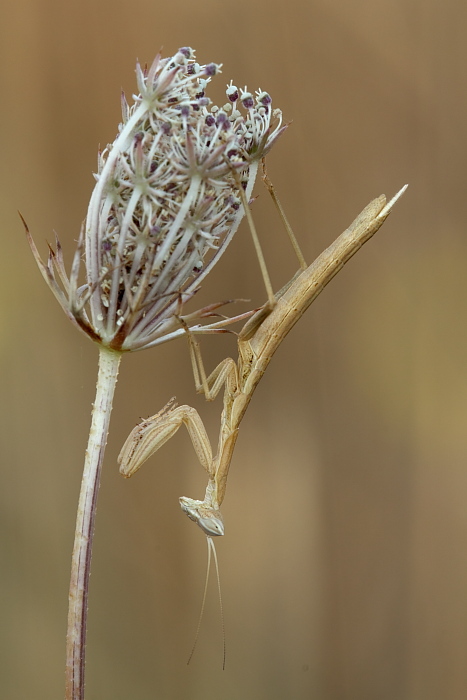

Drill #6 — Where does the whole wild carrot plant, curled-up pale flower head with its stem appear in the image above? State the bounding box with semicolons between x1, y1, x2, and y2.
26;47;286;700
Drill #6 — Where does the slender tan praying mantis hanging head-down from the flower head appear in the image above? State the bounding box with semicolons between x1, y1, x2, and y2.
118;176;407;547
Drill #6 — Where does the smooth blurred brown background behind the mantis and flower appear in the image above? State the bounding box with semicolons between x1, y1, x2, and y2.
0;0;467;700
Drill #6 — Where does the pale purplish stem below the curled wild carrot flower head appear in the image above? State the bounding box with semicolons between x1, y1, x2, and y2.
65;347;121;700
